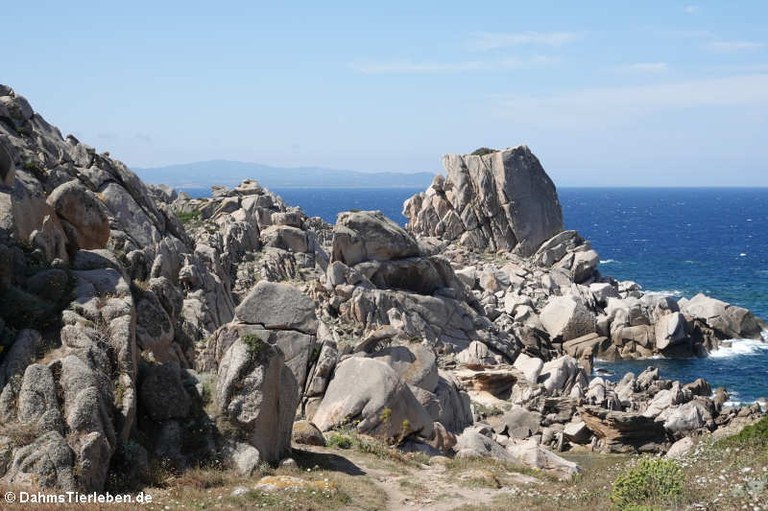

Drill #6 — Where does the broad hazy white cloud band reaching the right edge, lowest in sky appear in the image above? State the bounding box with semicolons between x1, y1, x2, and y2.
501;74;768;128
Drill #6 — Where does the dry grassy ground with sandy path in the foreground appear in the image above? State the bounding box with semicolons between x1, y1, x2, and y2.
0;419;768;511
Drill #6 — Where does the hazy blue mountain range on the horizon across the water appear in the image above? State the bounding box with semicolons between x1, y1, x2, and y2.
133;160;434;189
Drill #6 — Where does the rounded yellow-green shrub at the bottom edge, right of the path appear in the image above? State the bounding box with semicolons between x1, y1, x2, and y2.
611;458;684;511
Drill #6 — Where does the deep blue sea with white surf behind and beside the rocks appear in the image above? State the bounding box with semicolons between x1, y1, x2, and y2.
186;188;768;404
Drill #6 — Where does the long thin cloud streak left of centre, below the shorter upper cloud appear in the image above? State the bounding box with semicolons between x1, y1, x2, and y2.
350;55;556;75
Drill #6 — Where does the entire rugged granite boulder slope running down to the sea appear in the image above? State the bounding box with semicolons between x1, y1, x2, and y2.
0;86;765;491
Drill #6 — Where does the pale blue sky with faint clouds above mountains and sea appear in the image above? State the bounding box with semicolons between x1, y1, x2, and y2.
0;0;768;186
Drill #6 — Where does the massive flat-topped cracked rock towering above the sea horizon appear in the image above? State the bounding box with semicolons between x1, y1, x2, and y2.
403;146;563;257
